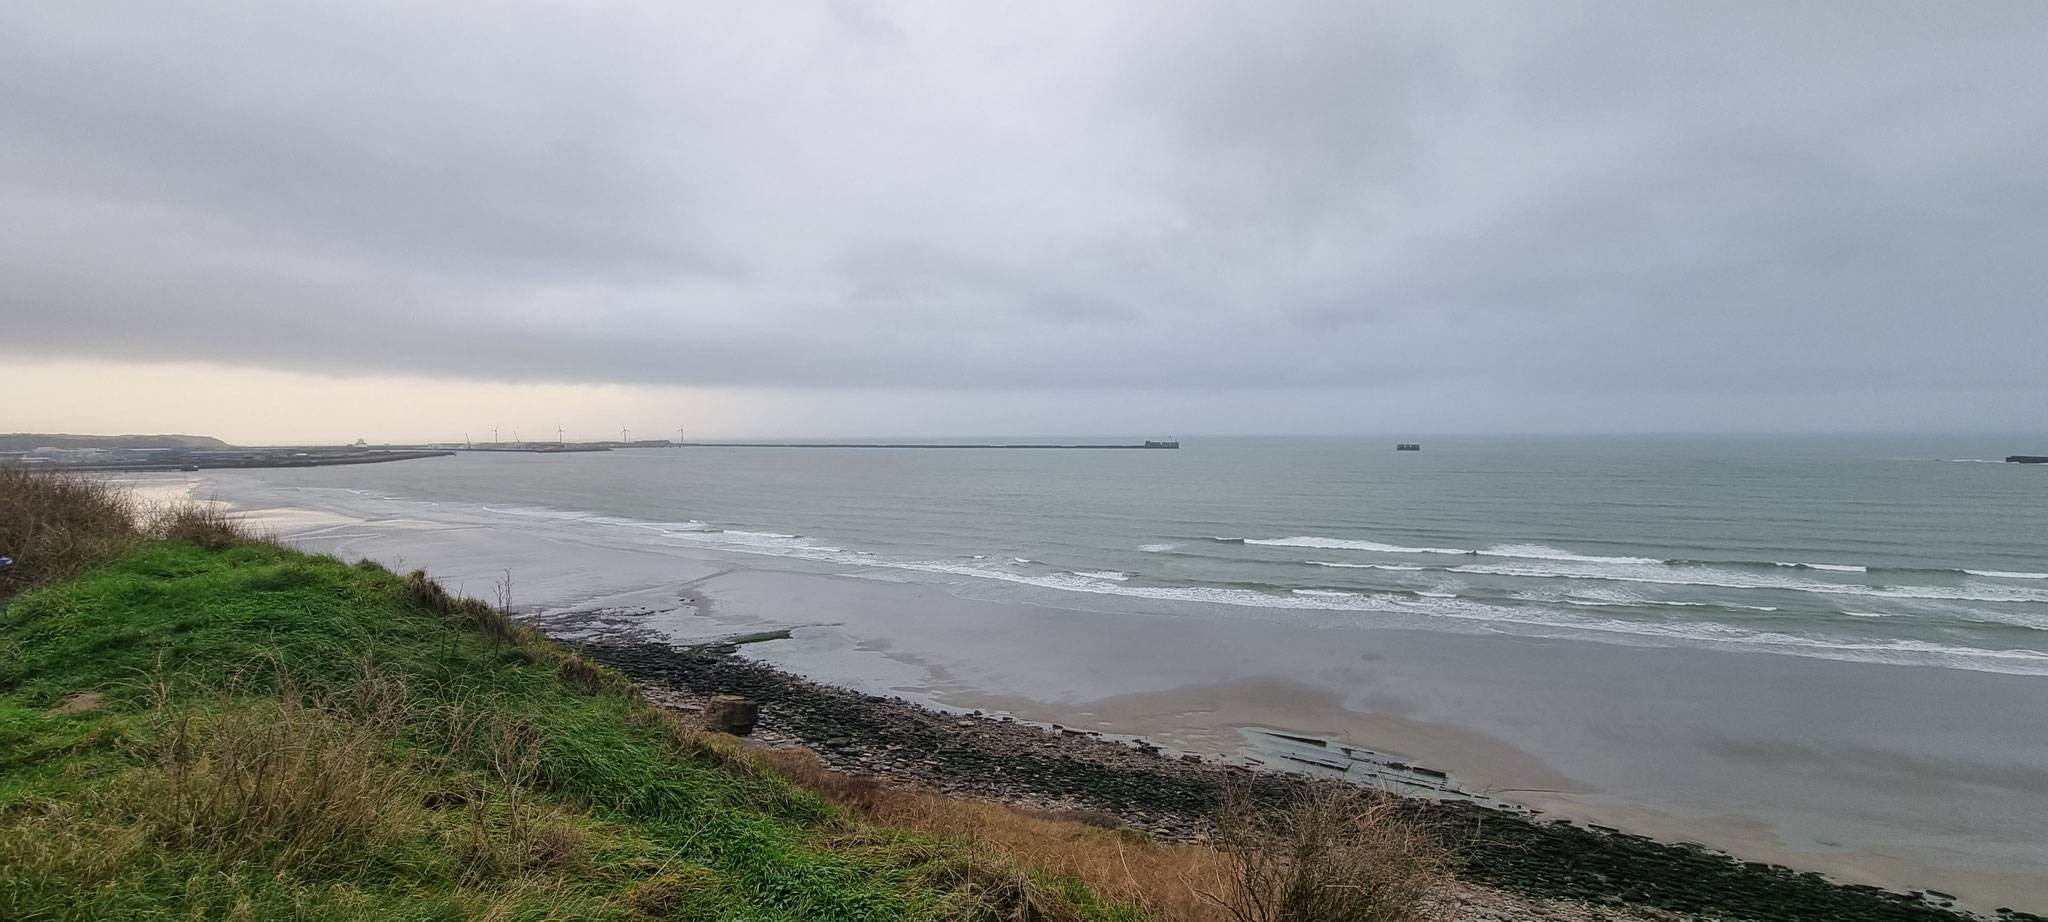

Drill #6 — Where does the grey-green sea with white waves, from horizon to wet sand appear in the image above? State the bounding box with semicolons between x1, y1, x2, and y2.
199;434;2048;674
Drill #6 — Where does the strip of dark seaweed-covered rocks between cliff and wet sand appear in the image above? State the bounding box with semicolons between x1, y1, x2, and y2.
569;635;2023;922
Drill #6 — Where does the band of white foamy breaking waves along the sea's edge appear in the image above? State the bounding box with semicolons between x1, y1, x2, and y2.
360;497;2048;676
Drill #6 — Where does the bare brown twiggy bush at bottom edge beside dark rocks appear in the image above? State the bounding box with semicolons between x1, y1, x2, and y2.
1204;783;1448;922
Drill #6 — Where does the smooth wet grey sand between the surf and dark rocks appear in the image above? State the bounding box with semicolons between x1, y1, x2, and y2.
184;473;2048;912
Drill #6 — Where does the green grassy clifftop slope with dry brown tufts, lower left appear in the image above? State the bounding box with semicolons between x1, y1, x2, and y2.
0;541;1137;920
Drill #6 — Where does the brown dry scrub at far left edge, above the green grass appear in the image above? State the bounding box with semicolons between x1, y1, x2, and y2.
0;463;141;598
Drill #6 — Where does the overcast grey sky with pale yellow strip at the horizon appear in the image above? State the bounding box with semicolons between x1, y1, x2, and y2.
0;0;2048;441
